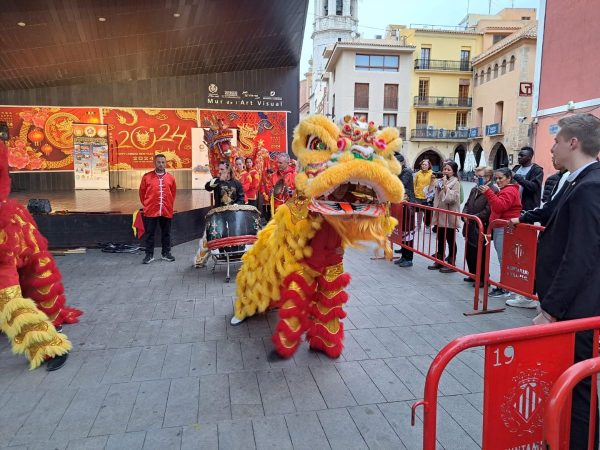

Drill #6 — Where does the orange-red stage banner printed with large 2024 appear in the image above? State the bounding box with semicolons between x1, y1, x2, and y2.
102;108;197;170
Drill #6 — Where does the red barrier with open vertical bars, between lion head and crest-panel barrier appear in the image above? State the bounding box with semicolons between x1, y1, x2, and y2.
389;202;492;315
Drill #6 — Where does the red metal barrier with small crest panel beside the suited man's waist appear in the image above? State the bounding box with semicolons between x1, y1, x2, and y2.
483;219;544;310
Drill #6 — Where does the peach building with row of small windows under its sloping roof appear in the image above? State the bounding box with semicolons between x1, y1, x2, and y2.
469;21;537;169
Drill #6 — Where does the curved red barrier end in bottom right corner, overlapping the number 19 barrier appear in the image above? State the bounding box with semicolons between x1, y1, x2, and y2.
544;356;600;450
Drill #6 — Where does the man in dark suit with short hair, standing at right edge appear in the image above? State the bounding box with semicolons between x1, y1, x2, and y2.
534;114;600;449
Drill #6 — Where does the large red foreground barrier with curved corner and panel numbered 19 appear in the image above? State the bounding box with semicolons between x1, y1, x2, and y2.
411;317;600;450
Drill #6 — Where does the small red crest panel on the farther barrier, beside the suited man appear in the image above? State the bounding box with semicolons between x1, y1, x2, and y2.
500;226;537;294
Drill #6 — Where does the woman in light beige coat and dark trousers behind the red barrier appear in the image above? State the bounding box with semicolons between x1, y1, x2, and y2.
427;161;460;273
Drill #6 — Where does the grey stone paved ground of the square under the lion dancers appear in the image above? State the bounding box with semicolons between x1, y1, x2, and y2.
0;236;534;450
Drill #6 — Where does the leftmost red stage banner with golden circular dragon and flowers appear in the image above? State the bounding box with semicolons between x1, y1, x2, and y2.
0;106;100;171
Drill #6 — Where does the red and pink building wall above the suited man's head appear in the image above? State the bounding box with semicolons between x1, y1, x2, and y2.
531;0;600;175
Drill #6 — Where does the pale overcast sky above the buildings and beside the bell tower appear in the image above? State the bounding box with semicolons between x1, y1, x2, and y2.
300;0;540;78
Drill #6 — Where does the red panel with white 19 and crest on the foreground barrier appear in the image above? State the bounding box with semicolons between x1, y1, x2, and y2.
482;333;575;450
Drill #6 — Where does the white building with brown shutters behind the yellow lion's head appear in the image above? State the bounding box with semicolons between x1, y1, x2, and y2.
324;38;415;139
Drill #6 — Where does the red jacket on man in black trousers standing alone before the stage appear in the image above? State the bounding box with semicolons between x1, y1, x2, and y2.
140;170;177;218
